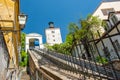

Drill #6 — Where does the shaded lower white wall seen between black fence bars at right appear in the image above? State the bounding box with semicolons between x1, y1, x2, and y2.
97;24;120;60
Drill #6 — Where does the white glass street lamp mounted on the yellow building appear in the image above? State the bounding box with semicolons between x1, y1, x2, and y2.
18;13;27;30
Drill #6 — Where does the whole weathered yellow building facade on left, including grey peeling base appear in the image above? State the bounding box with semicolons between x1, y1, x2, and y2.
0;0;21;80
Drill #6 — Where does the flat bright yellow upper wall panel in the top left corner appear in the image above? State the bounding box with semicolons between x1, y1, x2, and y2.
0;0;14;27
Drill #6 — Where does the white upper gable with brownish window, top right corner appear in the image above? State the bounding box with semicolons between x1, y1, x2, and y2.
93;0;120;20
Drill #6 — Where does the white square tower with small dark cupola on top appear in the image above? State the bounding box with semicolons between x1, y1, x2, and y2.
45;22;62;45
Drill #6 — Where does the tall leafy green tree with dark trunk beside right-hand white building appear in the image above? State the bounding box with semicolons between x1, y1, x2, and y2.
67;15;103;57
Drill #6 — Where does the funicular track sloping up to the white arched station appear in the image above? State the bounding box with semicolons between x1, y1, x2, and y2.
27;49;120;80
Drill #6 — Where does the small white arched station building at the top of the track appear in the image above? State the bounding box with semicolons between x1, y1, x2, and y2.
25;33;44;52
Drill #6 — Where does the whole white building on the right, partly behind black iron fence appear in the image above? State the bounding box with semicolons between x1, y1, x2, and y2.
93;0;120;60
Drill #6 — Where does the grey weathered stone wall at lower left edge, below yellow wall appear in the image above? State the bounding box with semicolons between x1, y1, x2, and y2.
0;33;9;80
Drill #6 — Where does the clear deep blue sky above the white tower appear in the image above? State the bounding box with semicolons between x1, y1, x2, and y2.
20;0;101;43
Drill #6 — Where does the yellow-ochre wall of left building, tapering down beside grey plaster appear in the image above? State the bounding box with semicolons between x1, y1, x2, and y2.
0;0;20;66
